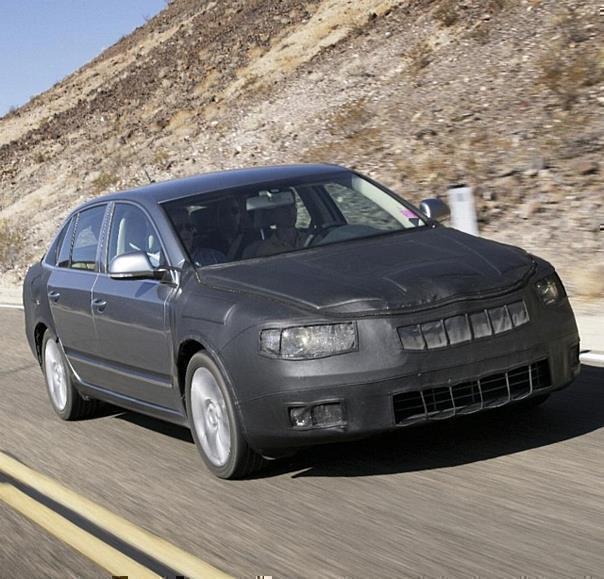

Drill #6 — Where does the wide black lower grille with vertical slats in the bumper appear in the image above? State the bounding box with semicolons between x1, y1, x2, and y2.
393;359;551;424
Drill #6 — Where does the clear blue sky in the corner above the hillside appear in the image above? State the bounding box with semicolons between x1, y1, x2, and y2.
0;0;166;116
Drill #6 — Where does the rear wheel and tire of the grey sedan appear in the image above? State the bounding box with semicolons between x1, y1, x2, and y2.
42;330;99;420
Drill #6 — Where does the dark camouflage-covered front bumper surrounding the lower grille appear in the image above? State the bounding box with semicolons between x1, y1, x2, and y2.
229;298;579;455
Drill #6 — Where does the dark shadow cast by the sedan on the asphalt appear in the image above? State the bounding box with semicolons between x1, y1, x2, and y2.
101;366;604;479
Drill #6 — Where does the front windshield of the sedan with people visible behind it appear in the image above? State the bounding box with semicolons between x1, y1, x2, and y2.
164;171;425;267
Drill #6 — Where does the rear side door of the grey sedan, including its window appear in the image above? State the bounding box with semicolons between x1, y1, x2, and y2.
47;204;107;382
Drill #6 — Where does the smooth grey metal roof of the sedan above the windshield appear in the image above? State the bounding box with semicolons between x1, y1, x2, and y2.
78;164;348;209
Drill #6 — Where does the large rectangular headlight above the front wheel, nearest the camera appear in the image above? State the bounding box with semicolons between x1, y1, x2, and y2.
260;322;357;360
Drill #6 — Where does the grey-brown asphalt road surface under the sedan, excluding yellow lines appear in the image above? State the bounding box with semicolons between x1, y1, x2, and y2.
0;310;604;577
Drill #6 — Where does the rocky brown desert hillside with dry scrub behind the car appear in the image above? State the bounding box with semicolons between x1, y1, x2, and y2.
0;0;604;297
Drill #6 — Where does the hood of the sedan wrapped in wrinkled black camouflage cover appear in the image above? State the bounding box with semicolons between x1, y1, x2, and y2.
199;227;534;315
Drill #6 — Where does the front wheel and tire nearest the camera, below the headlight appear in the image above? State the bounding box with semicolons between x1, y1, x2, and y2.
185;352;264;479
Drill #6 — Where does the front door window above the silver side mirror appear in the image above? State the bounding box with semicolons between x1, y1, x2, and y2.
107;203;165;267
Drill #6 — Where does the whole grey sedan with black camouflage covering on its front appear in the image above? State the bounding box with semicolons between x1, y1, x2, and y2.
23;165;579;478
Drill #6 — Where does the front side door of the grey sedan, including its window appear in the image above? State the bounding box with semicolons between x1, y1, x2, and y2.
92;202;179;408
